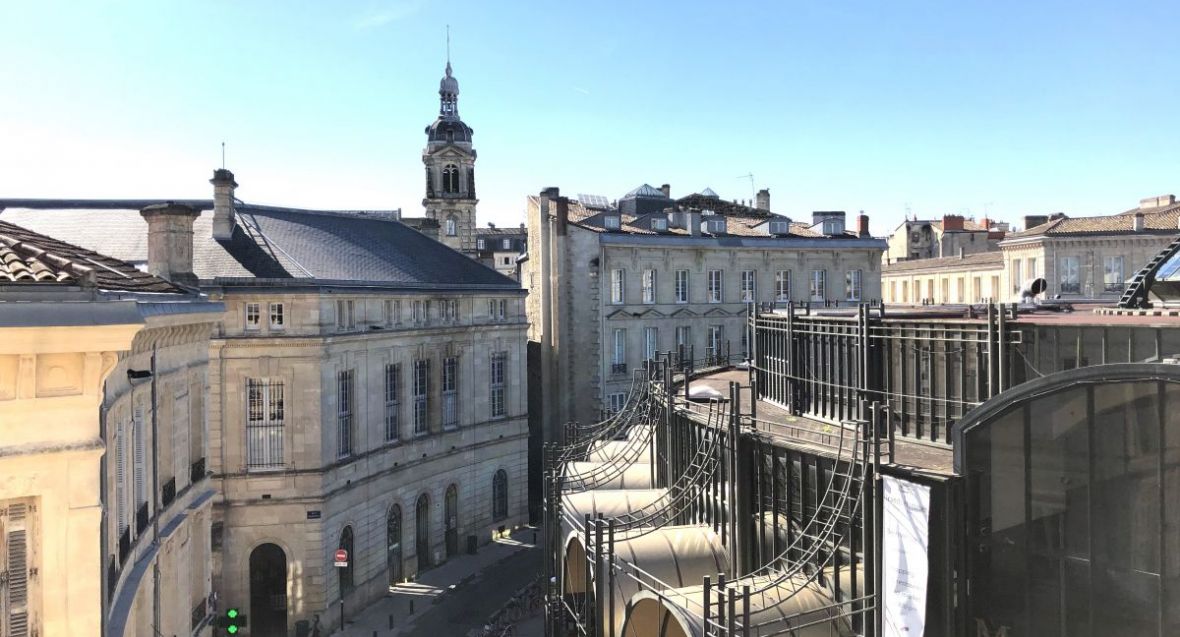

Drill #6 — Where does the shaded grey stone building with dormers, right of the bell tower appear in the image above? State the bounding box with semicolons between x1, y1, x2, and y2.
522;185;885;427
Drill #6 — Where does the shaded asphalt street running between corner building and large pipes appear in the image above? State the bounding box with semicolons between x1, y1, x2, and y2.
407;547;540;637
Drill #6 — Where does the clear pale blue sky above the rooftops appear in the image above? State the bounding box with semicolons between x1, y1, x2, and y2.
0;0;1180;234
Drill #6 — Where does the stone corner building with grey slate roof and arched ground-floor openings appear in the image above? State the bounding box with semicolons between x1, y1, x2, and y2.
0;170;527;637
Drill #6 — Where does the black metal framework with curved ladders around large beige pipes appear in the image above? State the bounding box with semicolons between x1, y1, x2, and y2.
544;351;887;637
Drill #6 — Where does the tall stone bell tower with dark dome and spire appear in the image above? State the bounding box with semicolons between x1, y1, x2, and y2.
422;46;479;256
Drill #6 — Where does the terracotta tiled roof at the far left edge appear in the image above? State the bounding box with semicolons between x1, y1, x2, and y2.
0;221;184;294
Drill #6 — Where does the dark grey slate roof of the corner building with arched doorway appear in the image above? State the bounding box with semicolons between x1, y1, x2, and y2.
0;199;519;288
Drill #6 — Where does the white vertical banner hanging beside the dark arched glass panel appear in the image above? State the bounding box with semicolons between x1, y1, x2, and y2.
880;475;930;637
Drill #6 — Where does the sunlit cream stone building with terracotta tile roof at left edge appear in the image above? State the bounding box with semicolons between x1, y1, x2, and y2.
0;222;222;637
